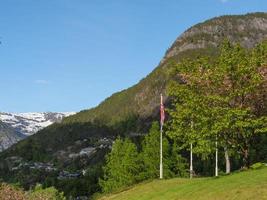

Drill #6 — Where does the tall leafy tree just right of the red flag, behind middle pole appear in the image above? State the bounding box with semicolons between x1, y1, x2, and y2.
167;58;215;177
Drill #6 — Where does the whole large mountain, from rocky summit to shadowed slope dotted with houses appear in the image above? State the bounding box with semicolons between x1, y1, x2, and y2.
0;13;267;198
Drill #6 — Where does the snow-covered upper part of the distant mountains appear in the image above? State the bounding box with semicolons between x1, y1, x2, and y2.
0;112;75;136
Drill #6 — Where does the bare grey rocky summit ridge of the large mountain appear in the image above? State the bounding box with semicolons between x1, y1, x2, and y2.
164;13;267;63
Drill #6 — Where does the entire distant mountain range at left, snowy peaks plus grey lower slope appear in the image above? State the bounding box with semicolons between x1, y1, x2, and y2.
0;112;75;151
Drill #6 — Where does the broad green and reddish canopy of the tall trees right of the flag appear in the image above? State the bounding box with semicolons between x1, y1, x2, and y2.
168;41;267;167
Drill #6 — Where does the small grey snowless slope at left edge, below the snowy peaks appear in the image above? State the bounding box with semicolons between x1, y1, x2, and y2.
0;121;25;152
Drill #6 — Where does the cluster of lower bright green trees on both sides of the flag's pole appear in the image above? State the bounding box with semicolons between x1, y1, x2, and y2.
99;122;188;192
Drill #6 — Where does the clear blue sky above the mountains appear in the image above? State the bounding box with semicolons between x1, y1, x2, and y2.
0;0;267;112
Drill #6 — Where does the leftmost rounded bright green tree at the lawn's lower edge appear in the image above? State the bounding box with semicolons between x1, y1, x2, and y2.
99;138;141;192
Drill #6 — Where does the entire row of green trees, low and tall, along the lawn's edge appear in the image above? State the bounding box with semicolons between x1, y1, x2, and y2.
99;41;267;192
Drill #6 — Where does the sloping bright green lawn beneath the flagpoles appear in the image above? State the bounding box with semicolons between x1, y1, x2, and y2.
98;167;267;200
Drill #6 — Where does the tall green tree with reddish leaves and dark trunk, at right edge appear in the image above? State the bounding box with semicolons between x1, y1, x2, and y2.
209;41;267;169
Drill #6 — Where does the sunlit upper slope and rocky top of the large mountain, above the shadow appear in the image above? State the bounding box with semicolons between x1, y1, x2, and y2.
63;13;267;124
